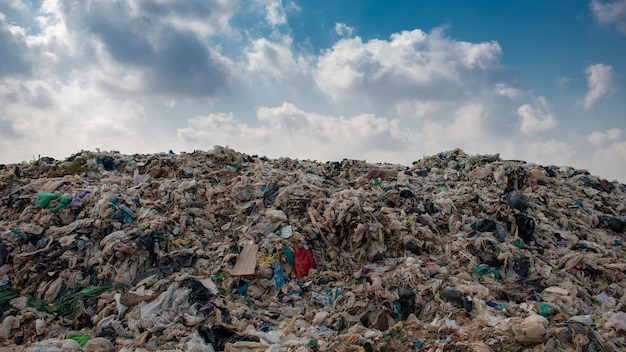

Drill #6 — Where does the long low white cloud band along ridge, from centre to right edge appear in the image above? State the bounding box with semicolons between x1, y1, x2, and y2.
175;95;626;178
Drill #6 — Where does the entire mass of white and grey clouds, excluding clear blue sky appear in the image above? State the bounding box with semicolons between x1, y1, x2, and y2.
0;0;626;182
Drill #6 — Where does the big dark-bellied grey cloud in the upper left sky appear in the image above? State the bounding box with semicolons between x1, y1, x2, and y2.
7;0;236;98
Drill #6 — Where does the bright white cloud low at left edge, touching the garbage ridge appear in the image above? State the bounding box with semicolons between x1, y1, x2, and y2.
0;80;154;162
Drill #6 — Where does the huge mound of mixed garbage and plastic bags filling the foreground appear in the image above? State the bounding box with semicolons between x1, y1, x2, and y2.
0;146;626;352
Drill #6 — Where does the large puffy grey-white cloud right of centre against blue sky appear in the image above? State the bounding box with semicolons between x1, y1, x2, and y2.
314;29;502;101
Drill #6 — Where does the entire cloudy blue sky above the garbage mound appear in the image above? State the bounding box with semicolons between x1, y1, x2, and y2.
0;0;626;182
